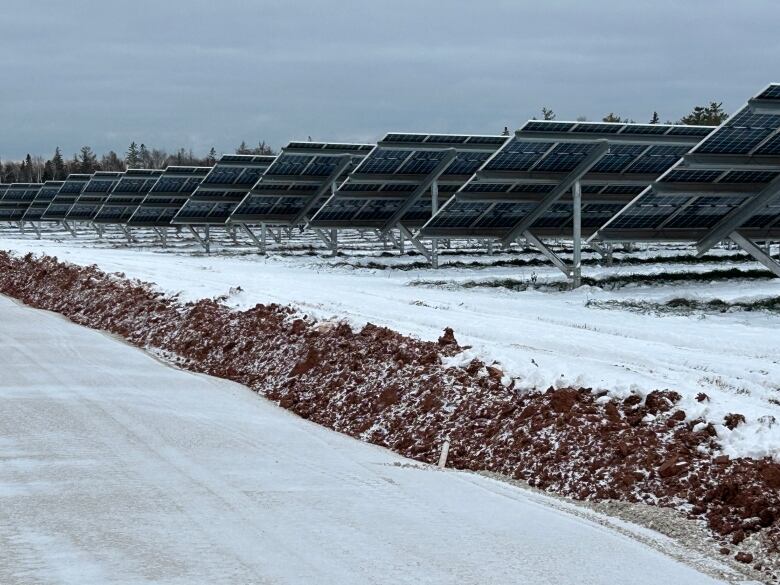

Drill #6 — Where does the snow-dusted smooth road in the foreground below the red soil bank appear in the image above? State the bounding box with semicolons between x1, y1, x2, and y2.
0;297;732;585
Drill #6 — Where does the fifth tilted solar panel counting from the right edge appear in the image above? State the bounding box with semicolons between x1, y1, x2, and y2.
173;154;276;225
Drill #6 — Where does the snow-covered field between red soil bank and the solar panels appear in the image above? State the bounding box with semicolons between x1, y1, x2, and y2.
0;228;780;457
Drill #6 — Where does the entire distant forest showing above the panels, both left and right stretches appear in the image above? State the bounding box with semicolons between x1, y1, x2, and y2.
0;102;728;183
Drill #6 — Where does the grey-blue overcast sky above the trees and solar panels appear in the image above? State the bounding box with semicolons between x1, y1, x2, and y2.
0;0;780;158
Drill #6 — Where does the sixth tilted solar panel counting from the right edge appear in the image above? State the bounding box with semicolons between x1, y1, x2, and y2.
127;166;212;227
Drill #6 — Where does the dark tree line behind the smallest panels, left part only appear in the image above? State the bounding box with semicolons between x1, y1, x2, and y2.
0;141;274;183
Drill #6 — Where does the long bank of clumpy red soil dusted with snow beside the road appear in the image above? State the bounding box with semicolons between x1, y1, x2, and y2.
0;253;780;572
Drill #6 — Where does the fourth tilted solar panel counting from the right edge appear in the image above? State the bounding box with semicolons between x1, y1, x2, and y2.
229;142;373;225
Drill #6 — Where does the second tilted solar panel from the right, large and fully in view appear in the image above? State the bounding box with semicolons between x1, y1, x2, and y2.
420;120;713;239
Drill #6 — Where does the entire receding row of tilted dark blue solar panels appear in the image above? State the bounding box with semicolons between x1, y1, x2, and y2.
0;84;780;245
